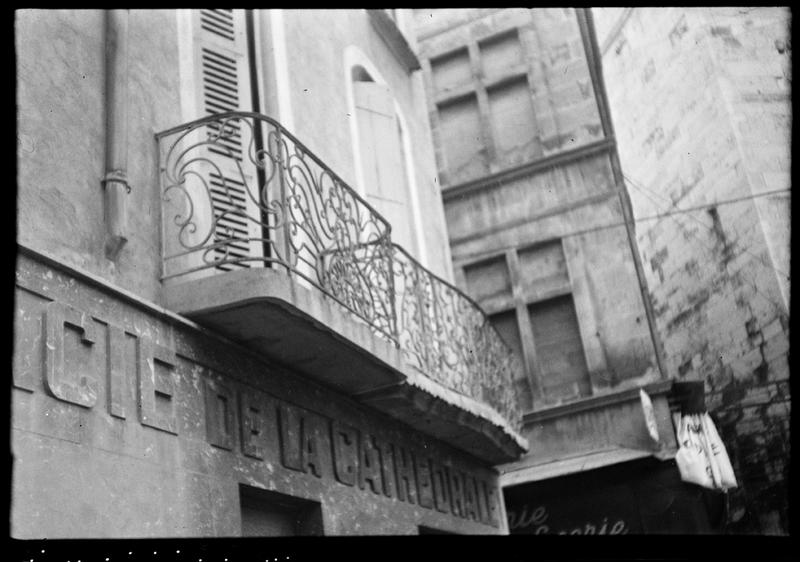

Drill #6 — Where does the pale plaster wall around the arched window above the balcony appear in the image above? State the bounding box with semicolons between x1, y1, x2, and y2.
284;10;452;279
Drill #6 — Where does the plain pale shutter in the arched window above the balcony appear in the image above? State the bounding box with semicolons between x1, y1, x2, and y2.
353;82;417;252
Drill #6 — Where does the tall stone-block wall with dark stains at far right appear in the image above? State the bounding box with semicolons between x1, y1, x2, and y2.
593;7;792;534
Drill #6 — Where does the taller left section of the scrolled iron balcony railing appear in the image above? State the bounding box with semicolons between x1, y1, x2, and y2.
157;112;394;338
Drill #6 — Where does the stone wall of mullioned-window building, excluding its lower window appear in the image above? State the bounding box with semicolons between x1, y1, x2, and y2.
414;8;659;410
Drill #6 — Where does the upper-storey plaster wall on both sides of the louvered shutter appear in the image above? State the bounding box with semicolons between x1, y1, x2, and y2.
16;10;451;302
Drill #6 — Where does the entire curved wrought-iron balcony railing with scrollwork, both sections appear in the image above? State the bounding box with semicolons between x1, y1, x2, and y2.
156;112;521;430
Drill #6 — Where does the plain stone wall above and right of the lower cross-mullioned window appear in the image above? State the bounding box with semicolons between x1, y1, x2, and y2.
445;155;658;393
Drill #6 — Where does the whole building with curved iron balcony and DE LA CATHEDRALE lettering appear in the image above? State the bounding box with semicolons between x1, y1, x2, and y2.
11;10;524;539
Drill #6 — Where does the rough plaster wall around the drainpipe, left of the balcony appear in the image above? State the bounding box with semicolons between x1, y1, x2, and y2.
16;10;180;302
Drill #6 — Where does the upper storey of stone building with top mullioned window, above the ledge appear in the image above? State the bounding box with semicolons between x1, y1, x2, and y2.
415;8;603;186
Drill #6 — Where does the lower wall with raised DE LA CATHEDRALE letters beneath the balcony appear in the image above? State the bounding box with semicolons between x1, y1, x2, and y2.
11;252;506;538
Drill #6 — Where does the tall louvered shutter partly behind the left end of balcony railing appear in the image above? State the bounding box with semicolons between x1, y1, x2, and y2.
193;9;263;271
